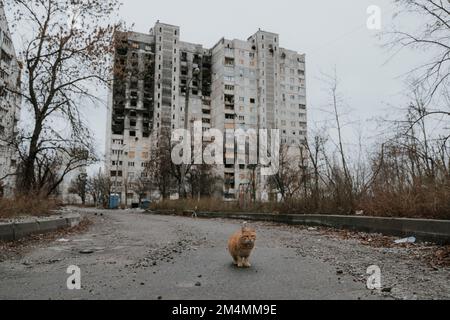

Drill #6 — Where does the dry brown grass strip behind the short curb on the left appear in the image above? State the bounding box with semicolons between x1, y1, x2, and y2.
0;196;60;219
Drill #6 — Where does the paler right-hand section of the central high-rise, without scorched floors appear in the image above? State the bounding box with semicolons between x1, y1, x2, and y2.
212;30;307;199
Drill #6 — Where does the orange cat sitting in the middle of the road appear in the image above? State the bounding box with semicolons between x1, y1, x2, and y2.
228;223;256;268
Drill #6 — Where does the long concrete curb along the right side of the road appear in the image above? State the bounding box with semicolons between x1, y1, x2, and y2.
150;212;450;244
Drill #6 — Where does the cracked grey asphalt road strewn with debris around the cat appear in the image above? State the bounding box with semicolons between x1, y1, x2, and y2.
0;209;450;300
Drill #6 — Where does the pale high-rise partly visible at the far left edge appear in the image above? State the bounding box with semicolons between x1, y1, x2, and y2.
0;2;20;196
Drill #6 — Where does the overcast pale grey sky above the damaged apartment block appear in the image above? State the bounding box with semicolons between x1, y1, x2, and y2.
14;0;428;170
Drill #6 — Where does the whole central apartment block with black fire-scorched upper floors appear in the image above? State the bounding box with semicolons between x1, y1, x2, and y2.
106;22;307;205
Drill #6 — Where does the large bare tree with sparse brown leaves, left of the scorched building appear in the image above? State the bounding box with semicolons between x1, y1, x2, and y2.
3;0;123;193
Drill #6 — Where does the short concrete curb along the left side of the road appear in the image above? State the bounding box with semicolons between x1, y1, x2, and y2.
0;214;81;241
